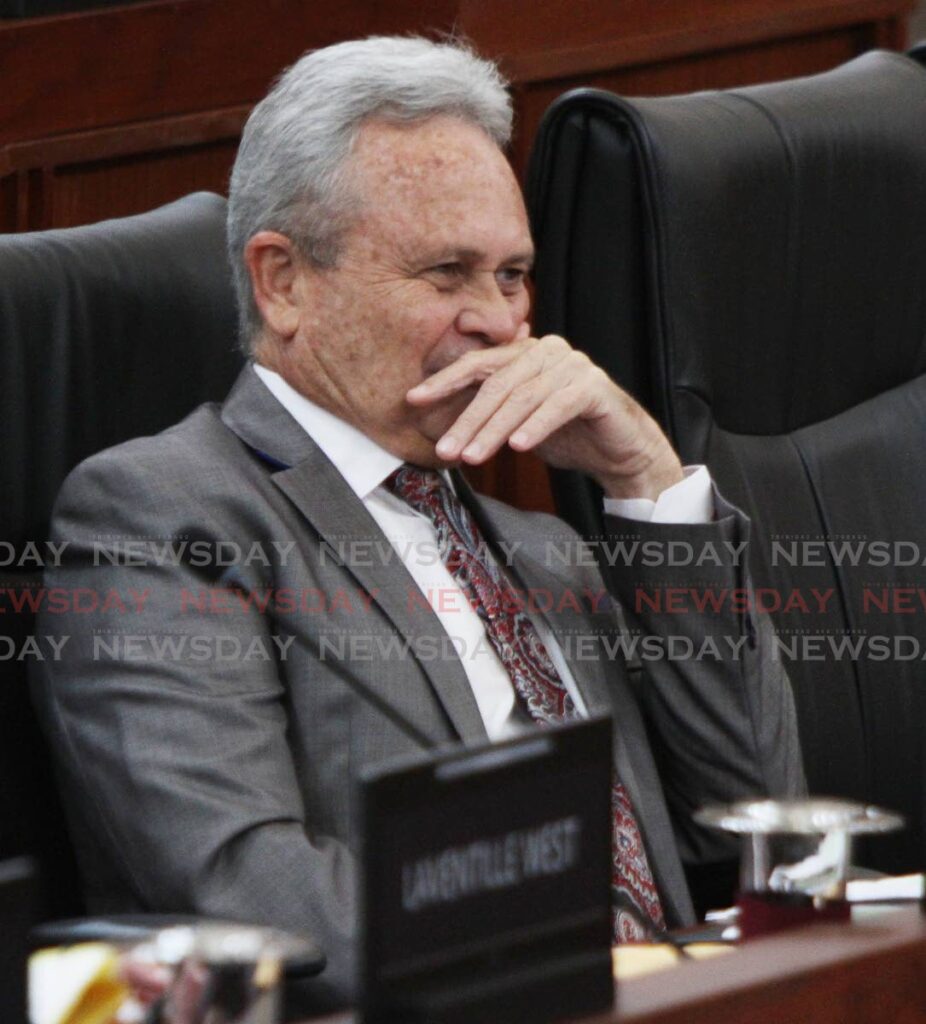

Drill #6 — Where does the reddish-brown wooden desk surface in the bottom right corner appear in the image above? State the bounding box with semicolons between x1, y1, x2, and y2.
315;907;926;1024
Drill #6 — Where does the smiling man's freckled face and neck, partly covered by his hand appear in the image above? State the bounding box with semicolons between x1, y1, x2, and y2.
280;117;533;465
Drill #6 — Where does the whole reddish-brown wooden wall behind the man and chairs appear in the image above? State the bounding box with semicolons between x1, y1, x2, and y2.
0;0;914;509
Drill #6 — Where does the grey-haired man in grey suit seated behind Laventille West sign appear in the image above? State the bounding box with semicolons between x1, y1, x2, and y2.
38;39;802;1002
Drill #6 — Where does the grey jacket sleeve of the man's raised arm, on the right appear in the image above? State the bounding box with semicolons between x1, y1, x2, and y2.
605;487;805;863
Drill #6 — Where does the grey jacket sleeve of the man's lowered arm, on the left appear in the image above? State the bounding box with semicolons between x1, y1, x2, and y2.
30;453;354;1006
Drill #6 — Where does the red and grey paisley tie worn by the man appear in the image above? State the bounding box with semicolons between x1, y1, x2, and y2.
385;465;666;942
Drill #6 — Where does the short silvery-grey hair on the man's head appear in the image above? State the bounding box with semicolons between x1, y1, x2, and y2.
228;36;511;352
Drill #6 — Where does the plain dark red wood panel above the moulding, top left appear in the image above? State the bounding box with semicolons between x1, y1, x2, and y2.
0;0;454;143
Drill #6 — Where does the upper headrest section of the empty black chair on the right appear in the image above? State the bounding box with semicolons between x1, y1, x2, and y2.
536;51;926;434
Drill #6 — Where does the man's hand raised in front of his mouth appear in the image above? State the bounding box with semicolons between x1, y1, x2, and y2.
407;325;682;500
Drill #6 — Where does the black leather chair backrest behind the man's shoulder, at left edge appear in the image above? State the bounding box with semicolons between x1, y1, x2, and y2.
0;194;242;915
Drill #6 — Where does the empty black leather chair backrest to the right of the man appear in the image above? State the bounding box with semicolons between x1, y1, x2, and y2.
529;52;926;870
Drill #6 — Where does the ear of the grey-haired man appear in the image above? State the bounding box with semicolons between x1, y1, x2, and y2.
245;231;304;341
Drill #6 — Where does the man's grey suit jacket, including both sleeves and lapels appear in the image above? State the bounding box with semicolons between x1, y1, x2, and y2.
35;368;803;1005
